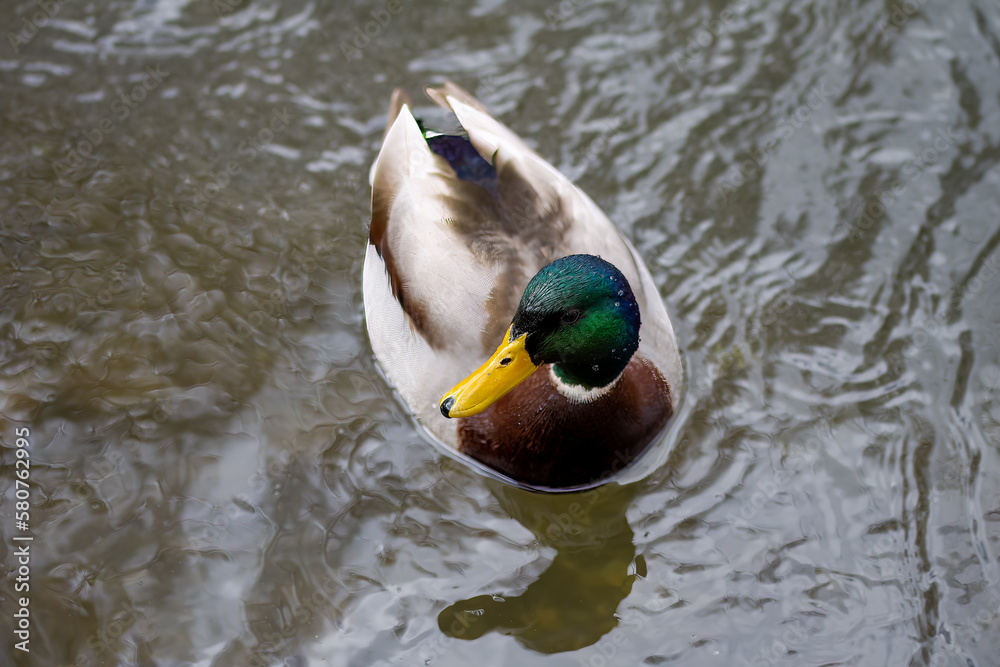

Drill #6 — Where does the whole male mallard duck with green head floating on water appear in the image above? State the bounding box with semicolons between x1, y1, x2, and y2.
364;83;683;490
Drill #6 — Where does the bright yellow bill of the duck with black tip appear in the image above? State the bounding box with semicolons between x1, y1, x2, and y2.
438;329;538;418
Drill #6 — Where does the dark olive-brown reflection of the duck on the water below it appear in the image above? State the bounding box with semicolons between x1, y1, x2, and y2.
438;480;646;653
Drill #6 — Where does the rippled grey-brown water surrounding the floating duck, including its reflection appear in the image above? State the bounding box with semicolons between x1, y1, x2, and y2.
0;0;1000;667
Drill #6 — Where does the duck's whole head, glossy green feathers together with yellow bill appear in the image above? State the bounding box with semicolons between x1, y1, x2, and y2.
439;255;640;418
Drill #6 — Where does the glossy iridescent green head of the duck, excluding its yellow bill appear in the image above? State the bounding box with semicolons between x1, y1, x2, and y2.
510;255;640;389
